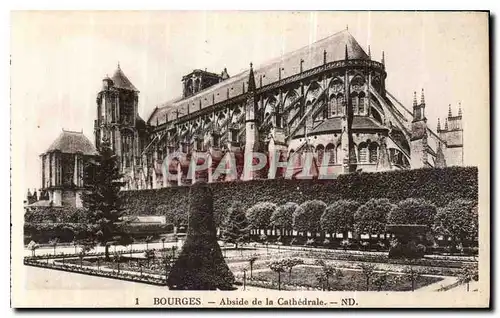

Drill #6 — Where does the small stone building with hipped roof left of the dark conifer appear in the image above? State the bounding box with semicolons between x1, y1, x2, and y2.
37;130;97;207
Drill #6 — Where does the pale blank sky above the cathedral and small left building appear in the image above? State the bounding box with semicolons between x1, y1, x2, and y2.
11;11;489;188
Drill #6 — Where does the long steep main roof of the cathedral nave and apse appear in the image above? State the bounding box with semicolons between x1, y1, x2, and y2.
148;30;369;125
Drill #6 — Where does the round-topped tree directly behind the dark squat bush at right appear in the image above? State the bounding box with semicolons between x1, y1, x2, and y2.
388;198;437;229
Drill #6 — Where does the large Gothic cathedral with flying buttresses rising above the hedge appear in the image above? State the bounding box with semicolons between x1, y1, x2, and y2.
39;30;463;201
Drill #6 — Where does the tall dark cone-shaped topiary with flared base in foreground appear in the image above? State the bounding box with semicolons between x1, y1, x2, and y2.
167;183;235;290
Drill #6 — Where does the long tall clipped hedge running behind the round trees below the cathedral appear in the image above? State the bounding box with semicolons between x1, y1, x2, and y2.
123;167;478;224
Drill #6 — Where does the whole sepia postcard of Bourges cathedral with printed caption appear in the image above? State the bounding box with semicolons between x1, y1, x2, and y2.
10;11;490;309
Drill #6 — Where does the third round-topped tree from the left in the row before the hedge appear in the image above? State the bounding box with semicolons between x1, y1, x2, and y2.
293;200;326;237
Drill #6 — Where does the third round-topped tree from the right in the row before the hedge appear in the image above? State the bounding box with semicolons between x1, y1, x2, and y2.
354;199;393;235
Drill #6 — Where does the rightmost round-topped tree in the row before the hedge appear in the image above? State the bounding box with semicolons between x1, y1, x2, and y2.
434;199;478;246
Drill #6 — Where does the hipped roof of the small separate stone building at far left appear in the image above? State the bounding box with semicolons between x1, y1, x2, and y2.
46;130;97;155
